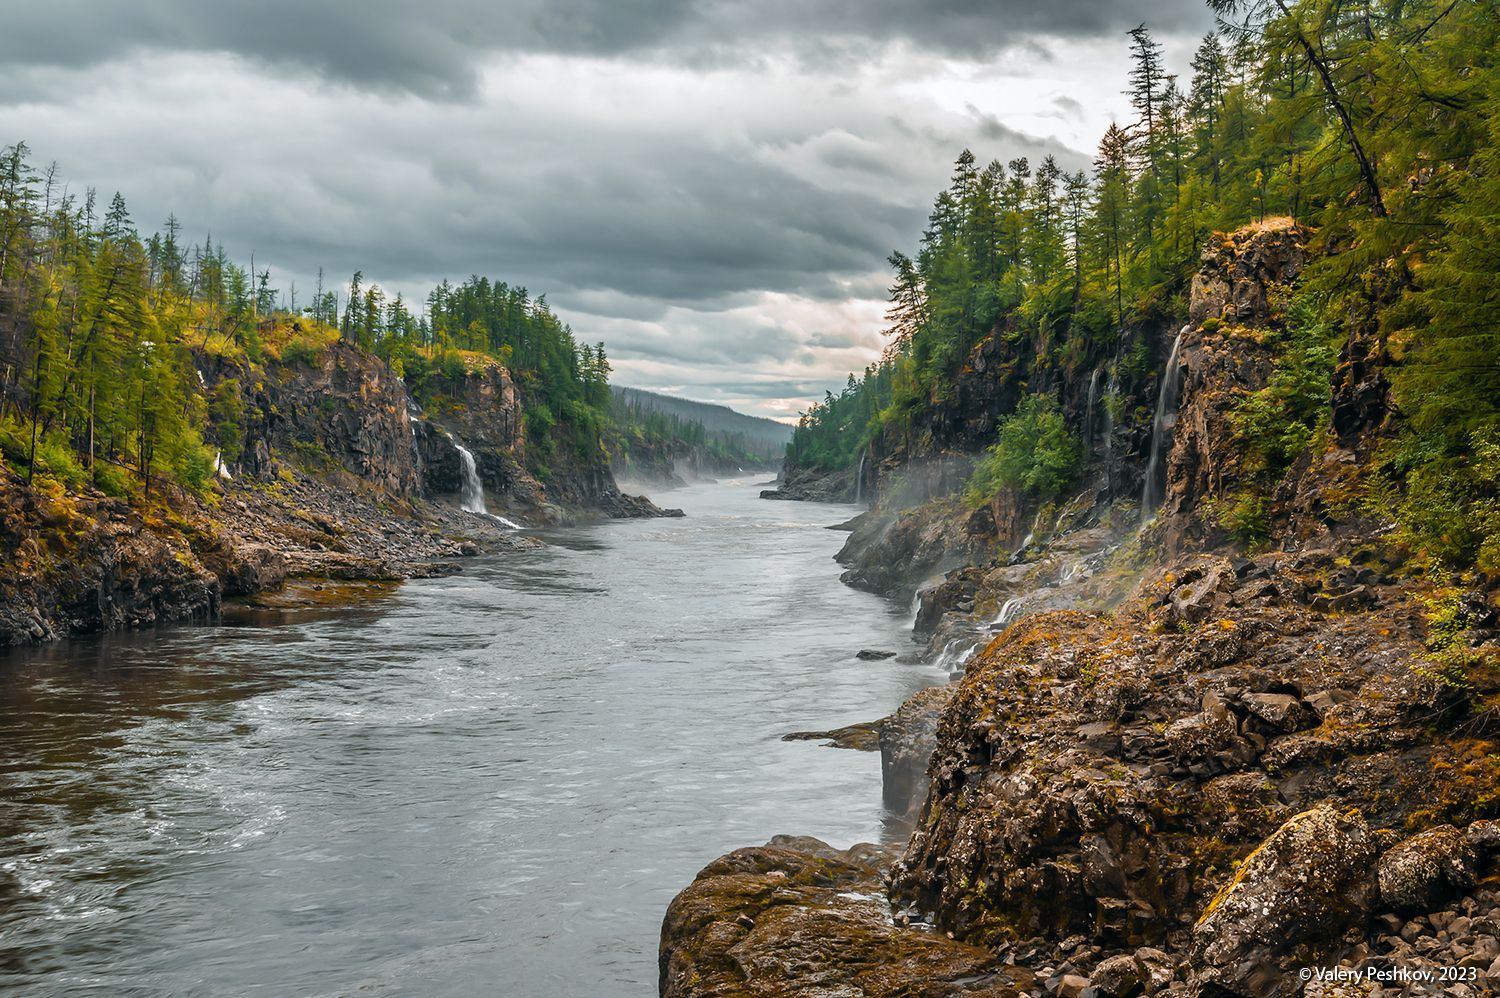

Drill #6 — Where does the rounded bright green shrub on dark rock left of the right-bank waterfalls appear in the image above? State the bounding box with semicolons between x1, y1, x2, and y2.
965;395;1083;506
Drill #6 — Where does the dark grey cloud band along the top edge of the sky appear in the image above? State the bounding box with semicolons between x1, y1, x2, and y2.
0;0;1211;98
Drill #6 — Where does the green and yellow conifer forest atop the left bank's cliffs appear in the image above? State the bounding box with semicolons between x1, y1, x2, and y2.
0;154;609;495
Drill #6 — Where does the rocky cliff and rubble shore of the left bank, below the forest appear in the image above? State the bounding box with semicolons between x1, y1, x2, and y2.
0;334;669;647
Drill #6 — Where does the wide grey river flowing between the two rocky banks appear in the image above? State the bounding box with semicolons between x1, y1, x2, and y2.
0;480;942;998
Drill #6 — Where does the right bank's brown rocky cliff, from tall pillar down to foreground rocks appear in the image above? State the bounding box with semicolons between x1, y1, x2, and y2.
662;222;1500;998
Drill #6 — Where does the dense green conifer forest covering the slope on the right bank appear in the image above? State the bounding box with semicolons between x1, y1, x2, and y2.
789;0;1500;569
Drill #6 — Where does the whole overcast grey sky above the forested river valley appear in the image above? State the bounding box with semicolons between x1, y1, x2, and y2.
0;0;1212;419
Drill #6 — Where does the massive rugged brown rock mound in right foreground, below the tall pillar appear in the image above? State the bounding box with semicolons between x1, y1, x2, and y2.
669;534;1500;996
